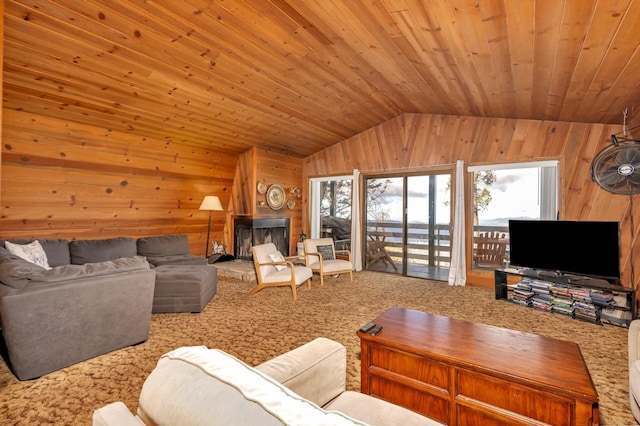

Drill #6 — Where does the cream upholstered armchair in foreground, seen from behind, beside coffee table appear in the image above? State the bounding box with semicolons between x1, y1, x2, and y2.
93;337;442;426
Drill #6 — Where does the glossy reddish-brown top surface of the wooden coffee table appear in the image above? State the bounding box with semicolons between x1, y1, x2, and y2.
358;308;598;402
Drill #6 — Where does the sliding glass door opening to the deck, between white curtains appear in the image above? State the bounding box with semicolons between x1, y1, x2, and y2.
364;173;451;280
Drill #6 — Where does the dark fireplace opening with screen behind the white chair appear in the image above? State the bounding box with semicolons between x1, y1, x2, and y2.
233;217;289;260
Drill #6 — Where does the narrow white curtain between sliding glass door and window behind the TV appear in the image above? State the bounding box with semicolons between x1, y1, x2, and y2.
449;160;467;285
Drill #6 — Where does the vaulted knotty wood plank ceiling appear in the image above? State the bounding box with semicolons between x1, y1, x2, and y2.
3;0;640;157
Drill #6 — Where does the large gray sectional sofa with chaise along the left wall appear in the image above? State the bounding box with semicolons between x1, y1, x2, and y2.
0;235;217;380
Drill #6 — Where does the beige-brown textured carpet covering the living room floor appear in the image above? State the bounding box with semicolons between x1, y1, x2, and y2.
0;272;636;425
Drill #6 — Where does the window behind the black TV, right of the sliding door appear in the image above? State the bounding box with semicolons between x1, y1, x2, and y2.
468;161;558;269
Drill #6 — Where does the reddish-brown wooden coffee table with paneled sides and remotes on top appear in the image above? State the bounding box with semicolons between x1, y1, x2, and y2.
358;308;599;425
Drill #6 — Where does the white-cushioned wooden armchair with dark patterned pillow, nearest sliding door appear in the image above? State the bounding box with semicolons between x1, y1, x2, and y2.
304;238;353;285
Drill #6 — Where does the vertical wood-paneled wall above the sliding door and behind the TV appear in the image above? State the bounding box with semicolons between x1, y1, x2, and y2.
303;114;640;286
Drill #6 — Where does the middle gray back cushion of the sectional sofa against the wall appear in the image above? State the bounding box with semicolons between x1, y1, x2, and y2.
69;237;138;265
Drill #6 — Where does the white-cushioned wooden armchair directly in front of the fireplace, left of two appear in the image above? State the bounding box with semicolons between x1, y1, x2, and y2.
249;243;313;300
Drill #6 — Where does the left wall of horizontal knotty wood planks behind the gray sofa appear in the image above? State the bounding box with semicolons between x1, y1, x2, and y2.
0;109;238;255
